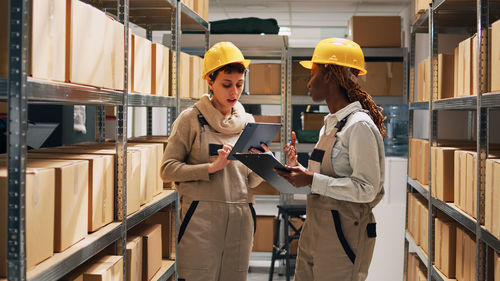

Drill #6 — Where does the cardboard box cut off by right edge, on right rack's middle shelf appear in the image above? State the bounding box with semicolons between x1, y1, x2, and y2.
484;159;500;238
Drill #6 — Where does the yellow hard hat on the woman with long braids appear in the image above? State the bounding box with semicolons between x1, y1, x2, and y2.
300;38;366;75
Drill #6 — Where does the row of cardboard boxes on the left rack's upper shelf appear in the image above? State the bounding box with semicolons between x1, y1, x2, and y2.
0;0;208;99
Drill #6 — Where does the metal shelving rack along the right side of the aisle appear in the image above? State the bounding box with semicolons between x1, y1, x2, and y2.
404;0;500;281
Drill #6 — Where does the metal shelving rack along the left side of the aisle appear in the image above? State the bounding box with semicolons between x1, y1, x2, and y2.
0;0;209;280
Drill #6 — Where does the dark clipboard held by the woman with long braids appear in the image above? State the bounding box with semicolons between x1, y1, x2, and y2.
234;153;311;194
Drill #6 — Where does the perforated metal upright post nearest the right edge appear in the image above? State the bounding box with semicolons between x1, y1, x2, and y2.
475;0;489;281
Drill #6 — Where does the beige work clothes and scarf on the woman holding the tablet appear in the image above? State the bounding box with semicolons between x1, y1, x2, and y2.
162;96;262;281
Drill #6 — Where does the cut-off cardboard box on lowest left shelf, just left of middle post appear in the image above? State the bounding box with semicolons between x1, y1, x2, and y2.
83;256;123;281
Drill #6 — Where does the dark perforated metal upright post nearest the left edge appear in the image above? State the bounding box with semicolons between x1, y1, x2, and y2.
6;0;31;276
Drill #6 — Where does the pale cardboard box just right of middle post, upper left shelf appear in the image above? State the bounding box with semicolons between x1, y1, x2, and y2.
131;34;152;94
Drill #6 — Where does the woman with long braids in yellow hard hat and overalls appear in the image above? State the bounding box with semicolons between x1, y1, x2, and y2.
278;38;385;281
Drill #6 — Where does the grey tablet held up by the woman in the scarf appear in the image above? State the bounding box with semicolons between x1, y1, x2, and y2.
227;123;281;160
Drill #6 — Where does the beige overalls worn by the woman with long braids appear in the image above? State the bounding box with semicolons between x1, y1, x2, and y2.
295;113;381;281
